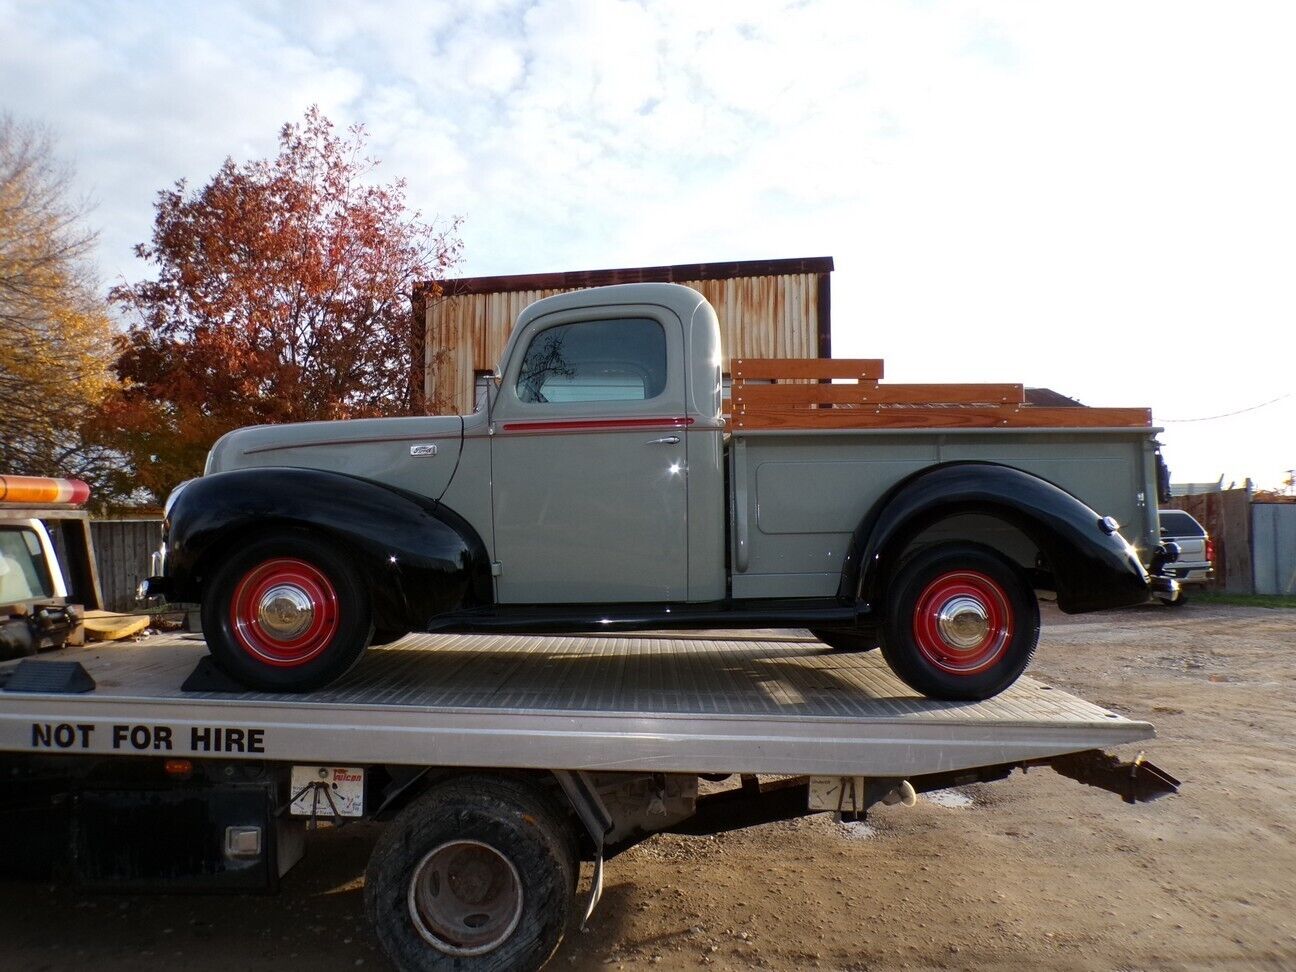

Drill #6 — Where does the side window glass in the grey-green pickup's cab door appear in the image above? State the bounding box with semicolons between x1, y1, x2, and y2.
517;318;666;404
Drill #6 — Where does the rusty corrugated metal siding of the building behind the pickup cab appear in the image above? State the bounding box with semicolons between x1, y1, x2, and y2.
424;272;827;412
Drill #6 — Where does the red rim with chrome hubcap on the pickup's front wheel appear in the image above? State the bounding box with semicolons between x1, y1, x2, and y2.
229;557;338;669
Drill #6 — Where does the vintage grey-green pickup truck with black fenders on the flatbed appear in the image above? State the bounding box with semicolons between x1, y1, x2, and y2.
146;284;1177;699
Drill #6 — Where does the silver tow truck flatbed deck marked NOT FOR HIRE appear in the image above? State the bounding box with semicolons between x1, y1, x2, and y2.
0;631;1155;776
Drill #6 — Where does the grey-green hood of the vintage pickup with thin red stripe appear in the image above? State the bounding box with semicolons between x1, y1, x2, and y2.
203;415;464;499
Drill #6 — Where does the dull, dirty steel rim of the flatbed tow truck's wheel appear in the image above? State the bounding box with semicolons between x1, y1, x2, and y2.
407;840;522;955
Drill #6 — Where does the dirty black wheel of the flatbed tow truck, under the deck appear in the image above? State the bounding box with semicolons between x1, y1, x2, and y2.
364;776;579;972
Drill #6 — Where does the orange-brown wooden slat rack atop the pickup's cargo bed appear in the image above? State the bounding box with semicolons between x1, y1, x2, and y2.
728;358;1152;429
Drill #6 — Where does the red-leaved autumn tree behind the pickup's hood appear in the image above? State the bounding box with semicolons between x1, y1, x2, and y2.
100;108;460;498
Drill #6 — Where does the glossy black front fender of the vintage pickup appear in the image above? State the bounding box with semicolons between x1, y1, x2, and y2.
165;467;492;630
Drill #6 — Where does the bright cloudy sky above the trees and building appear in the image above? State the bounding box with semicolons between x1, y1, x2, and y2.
0;0;1296;486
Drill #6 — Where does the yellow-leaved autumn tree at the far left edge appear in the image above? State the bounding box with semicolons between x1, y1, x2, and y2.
0;115;111;481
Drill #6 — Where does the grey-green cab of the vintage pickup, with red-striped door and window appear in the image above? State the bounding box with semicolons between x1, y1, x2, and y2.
476;286;726;604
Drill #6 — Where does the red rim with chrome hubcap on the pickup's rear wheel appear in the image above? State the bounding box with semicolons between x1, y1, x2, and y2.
914;570;1013;675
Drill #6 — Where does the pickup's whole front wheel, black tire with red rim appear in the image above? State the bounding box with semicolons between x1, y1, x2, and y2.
202;533;373;692
